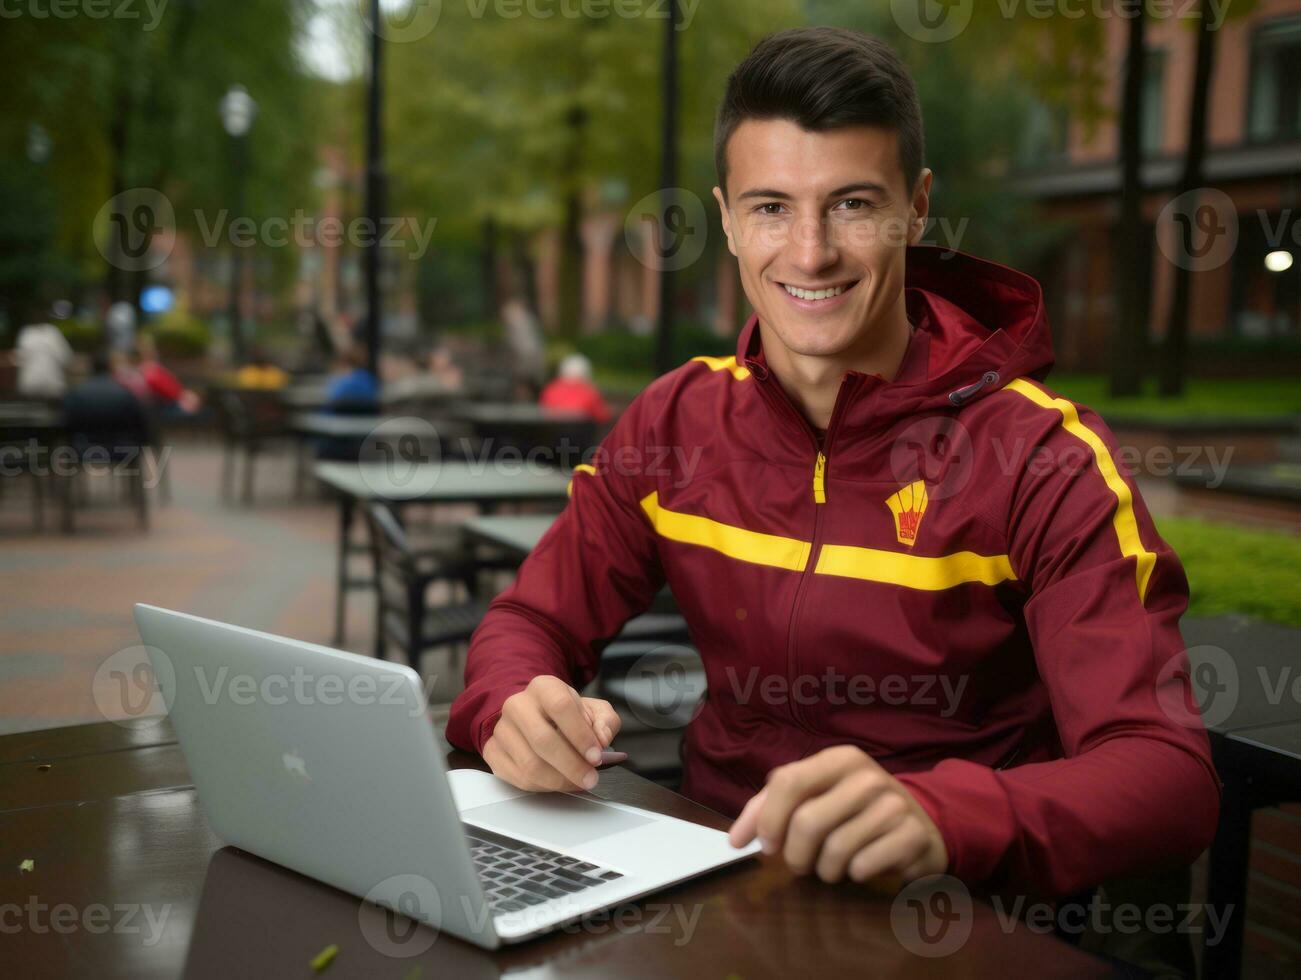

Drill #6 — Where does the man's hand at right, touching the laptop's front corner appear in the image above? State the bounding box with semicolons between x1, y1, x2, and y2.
727;746;948;882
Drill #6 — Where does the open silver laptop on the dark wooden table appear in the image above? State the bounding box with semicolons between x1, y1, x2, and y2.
135;604;758;949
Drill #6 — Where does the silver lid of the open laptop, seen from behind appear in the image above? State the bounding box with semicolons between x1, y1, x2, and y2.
135;604;500;947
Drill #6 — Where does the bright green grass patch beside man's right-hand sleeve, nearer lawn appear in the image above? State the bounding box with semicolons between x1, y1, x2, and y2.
1157;517;1301;627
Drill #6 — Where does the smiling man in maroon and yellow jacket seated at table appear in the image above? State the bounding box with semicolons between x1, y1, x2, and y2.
448;29;1218;895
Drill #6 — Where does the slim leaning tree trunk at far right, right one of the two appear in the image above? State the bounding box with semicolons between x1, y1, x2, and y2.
1159;0;1215;397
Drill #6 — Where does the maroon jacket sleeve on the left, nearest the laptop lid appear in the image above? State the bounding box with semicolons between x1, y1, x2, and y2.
448;396;665;752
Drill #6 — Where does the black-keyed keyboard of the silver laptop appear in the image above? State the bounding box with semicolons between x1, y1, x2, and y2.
464;824;623;912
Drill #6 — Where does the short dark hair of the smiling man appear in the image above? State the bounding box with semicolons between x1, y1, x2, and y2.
714;27;926;195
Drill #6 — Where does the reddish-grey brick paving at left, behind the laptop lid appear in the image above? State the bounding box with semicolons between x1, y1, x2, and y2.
0;445;372;733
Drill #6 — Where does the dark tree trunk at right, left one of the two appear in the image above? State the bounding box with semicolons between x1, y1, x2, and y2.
1108;4;1151;397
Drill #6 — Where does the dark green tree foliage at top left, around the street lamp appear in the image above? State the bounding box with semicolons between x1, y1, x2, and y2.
0;0;316;304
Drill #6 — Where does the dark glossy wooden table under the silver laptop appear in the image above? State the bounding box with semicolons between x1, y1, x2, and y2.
0;721;1110;980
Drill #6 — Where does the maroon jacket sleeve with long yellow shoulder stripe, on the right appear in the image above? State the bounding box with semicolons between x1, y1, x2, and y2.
899;388;1219;895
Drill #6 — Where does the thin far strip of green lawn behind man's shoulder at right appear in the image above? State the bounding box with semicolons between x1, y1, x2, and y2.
1047;374;1301;418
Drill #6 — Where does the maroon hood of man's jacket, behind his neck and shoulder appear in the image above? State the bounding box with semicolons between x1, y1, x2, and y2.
736;245;1053;419
